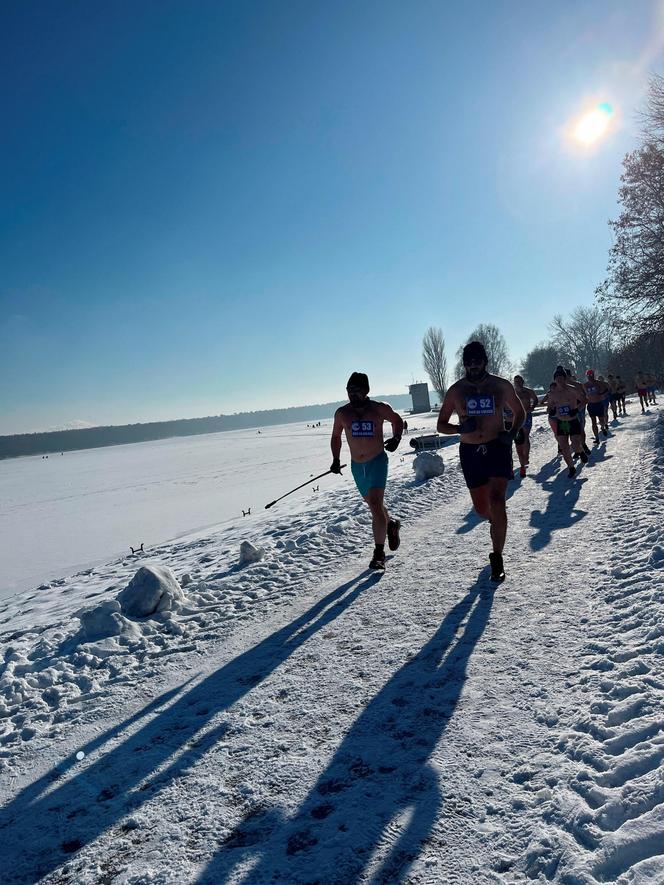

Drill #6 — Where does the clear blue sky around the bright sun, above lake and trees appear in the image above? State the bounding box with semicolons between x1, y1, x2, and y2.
0;0;662;433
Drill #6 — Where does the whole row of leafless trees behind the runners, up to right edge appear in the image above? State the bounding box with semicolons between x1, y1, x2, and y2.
422;75;664;402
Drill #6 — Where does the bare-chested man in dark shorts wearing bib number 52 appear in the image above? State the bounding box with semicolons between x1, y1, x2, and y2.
438;341;525;581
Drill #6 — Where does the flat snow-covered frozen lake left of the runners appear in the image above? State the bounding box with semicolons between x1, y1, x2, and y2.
0;420;344;598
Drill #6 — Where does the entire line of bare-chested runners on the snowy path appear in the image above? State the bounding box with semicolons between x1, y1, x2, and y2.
330;341;657;582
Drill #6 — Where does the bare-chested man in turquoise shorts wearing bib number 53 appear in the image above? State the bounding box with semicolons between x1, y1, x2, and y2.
330;372;403;570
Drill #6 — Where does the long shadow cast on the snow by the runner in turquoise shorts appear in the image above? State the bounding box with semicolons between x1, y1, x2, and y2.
0;572;379;883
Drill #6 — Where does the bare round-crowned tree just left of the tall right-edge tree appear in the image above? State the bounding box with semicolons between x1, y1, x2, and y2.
549;307;616;372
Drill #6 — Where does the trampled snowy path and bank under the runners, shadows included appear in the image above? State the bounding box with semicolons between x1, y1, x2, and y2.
0;406;664;885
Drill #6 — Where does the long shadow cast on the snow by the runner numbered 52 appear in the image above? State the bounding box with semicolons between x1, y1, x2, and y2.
198;576;493;885
